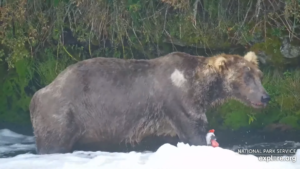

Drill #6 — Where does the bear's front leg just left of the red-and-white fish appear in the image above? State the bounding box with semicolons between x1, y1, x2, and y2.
165;106;208;145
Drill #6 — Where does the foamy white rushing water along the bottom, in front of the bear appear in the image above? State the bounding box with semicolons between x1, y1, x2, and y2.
0;129;300;169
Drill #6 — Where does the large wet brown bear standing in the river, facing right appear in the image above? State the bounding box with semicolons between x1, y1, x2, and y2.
30;52;270;154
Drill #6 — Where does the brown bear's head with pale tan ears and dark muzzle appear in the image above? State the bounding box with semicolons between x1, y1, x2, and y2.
207;52;270;108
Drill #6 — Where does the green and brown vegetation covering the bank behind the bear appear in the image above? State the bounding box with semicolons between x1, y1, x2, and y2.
0;0;300;129
